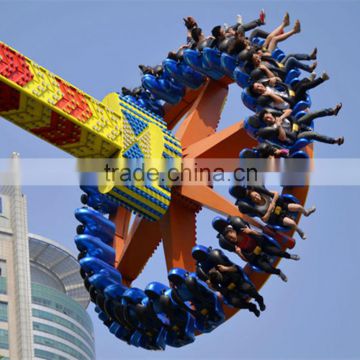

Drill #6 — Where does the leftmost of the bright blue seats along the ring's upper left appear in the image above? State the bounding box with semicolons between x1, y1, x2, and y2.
141;74;185;104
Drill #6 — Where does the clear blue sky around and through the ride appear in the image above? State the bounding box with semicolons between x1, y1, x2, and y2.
0;0;360;360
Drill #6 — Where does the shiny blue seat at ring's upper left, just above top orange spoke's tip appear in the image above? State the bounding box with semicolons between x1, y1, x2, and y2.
163;59;205;89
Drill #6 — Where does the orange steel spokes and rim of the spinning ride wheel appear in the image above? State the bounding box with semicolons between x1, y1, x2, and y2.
112;79;313;318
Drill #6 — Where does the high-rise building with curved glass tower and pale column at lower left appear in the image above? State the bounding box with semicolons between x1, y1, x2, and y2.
0;154;95;360
